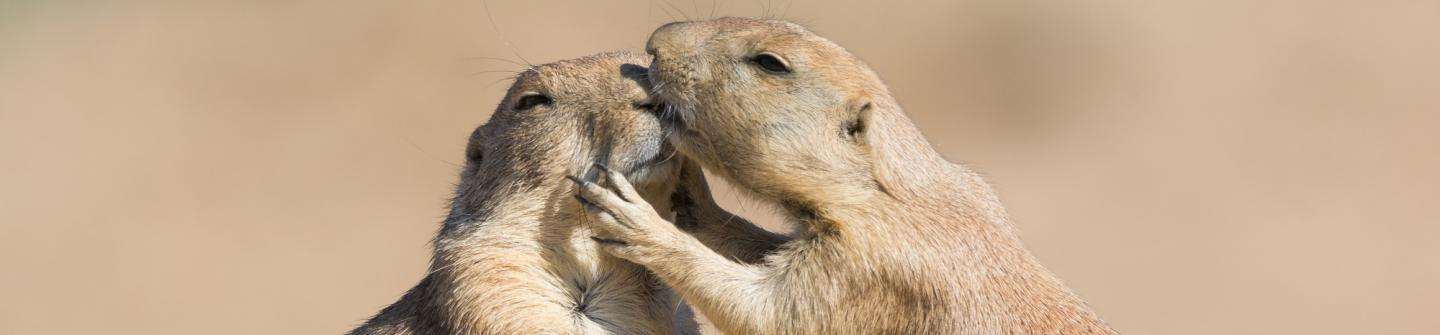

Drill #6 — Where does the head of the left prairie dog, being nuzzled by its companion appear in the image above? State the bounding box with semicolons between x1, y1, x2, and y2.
449;52;681;221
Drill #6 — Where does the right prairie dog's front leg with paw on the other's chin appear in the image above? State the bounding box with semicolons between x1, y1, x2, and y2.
570;167;780;334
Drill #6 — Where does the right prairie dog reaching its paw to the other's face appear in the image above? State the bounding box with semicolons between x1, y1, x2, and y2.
579;17;1115;334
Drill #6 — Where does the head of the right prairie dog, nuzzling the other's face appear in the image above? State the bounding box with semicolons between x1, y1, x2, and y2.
645;17;893;211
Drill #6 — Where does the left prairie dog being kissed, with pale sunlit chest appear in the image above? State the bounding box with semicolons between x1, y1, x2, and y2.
351;53;698;334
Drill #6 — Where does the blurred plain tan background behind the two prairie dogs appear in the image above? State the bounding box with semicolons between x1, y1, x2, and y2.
0;0;1440;335
